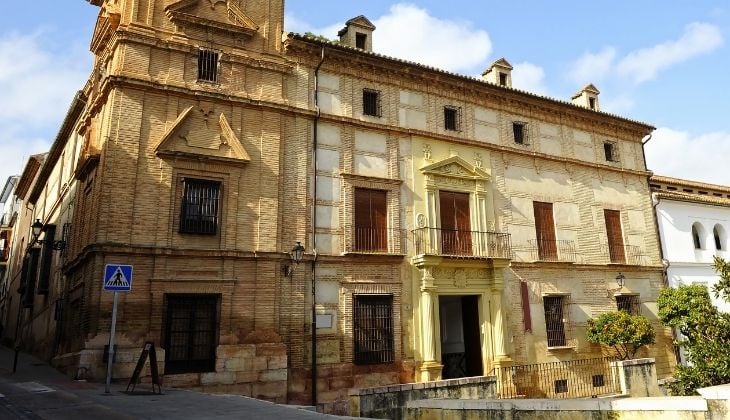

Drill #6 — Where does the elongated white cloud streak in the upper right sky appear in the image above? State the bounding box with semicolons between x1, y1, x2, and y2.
616;22;723;84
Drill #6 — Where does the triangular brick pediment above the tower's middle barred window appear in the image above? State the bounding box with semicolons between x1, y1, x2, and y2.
155;102;251;163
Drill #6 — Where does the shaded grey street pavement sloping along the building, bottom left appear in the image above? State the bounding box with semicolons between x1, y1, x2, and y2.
0;346;352;420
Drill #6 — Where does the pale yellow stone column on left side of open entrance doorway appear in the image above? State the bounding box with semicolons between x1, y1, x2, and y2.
420;267;443;382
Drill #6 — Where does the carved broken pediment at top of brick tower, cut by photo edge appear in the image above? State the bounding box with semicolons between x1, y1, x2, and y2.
165;0;258;36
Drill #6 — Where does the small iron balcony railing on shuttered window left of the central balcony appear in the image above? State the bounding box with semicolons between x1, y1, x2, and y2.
344;227;408;254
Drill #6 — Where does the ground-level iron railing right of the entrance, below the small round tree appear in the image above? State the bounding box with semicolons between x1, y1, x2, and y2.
492;357;621;399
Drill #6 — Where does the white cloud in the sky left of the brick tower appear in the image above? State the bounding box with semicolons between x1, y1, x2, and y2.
0;32;91;183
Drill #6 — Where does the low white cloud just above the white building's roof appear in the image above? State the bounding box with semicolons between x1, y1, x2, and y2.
645;127;730;185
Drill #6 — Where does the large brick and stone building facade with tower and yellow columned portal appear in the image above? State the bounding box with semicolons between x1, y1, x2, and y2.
4;0;673;402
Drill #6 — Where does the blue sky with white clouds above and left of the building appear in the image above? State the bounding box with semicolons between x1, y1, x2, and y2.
0;0;730;185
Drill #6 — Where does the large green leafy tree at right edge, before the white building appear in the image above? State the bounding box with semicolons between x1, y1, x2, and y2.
657;257;730;395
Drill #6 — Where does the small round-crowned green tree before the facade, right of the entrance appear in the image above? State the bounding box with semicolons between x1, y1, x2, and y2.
586;311;656;360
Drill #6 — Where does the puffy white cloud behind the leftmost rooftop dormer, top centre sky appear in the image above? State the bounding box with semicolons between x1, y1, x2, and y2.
284;3;492;74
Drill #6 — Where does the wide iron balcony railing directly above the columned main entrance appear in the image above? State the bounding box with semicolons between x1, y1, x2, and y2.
413;227;512;259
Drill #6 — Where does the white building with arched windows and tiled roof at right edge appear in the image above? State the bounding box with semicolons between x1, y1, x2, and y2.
650;175;730;312
